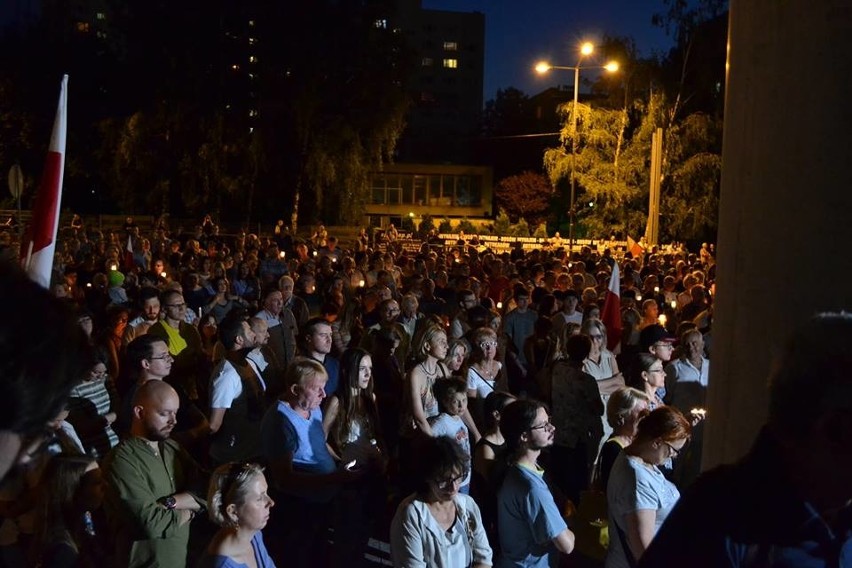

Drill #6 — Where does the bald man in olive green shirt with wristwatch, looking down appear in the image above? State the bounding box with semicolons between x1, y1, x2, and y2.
104;381;205;568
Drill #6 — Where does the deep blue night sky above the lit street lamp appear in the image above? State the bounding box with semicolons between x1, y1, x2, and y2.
423;0;672;101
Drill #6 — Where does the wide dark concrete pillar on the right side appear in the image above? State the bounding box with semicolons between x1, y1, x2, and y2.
704;0;852;469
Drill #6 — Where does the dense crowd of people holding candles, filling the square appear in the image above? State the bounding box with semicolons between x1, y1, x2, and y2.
0;217;848;567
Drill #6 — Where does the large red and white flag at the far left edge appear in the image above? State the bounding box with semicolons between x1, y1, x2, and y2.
20;75;68;288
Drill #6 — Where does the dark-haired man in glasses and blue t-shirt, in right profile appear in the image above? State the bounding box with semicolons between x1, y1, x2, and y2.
495;400;574;568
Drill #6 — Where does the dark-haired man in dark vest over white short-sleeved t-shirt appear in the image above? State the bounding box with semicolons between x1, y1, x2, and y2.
210;315;266;466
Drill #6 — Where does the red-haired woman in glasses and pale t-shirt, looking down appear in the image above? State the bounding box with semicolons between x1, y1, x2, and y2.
605;406;692;568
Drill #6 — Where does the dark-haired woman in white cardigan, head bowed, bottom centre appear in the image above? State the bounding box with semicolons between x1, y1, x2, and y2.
390;436;491;568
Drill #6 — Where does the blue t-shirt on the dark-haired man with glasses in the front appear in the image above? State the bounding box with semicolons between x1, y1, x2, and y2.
495;465;568;568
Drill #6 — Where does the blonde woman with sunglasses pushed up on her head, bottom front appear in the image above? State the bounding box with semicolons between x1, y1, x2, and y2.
198;463;275;568
